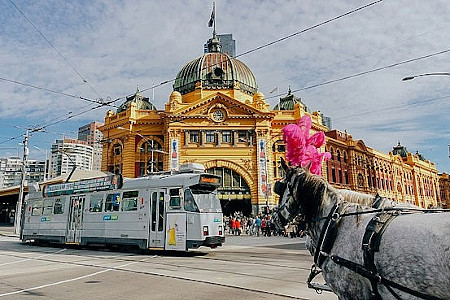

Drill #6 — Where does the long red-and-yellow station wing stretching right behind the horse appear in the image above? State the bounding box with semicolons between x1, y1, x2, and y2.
325;130;442;208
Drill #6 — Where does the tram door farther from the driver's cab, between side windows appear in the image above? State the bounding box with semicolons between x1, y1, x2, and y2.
66;196;85;244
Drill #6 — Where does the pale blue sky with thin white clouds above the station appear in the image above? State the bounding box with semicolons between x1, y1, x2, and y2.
0;0;450;173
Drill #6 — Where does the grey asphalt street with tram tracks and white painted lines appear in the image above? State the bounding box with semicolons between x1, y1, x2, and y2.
0;228;337;300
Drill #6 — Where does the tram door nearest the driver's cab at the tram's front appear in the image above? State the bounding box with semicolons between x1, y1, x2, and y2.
148;189;167;249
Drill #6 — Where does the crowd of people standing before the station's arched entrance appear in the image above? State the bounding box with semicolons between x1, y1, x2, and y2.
224;212;305;238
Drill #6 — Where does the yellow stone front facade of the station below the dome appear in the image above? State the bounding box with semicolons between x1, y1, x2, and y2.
101;85;326;213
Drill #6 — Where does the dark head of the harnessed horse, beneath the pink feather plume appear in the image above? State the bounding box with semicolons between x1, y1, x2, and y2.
273;159;327;227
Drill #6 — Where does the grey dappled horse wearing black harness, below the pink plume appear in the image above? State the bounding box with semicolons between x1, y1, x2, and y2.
273;161;450;300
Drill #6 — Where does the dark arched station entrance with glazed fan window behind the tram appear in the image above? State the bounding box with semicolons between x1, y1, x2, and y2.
206;167;252;216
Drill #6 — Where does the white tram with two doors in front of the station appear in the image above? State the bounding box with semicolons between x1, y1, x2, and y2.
22;164;225;251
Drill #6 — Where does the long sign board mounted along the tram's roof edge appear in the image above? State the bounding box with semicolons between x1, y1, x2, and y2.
43;174;123;197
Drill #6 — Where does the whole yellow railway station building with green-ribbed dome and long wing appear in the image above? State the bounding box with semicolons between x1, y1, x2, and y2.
99;33;440;215
